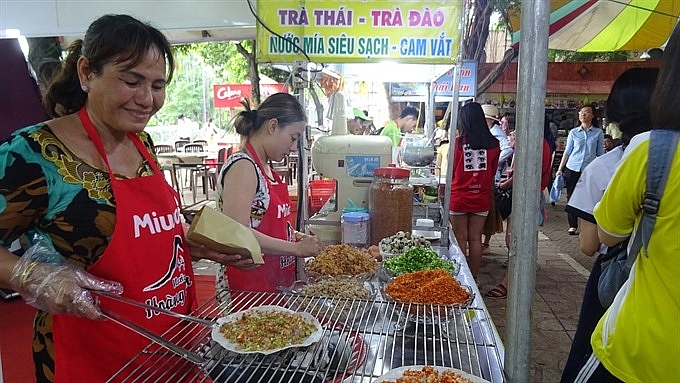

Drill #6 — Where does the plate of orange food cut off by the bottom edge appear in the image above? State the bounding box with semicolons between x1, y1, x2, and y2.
374;366;489;383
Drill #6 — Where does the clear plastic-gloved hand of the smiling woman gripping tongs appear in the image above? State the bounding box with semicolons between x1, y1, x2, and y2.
10;258;123;319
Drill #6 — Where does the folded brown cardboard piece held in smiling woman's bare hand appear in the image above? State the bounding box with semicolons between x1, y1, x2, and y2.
187;206;264;265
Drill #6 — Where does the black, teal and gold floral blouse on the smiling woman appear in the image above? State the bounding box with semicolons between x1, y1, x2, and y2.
0;123;153;382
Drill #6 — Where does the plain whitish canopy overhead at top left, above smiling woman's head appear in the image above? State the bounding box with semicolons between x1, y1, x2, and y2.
0;0;255;43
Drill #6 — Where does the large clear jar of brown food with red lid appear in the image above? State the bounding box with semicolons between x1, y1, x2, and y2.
368;167;413;245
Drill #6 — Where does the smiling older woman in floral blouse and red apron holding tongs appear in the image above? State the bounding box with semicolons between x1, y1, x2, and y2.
0;15;243;383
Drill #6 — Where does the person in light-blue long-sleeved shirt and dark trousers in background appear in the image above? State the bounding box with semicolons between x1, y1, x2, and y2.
555;105;604;235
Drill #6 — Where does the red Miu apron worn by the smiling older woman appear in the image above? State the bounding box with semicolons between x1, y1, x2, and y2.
53;108;196;383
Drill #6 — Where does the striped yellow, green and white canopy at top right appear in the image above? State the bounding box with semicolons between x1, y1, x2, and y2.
510;0;680;52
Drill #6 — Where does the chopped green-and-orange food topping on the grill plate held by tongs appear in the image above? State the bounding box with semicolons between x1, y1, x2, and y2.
220;311;316;351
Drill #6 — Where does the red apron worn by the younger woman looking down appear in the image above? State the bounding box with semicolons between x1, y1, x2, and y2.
227;143;296;293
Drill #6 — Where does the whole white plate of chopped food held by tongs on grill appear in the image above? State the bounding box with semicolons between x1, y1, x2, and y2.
212;306;323;354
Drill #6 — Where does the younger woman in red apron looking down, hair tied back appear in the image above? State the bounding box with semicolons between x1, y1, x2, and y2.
218;93;320;292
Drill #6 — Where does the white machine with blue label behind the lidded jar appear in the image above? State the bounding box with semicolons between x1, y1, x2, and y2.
307;134;392;243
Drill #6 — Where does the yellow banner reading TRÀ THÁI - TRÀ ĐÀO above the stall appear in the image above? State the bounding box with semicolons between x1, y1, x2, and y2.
257;0;463;64
